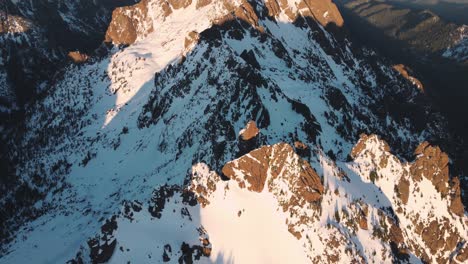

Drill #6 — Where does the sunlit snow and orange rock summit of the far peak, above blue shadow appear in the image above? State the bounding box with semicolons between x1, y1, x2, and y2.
99;0;348;131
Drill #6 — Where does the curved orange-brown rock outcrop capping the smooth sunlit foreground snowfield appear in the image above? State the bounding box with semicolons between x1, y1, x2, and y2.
222;143;324;239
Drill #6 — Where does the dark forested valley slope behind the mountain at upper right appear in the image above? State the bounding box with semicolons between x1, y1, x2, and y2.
338;0;468;176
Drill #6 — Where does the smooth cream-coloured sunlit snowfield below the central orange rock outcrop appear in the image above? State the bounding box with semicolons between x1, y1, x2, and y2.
200;184;308;263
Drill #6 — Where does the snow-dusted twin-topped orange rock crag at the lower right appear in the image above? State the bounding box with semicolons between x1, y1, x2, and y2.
351;135;466;263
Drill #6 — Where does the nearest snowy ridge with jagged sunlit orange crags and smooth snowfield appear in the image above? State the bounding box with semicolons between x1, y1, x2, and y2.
61;135;468;263
